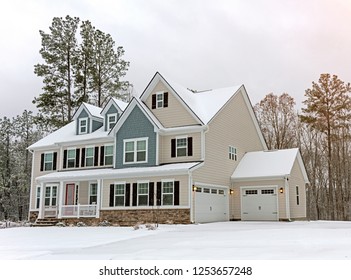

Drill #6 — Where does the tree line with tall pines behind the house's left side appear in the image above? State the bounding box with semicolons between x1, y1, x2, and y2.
0;15;132;220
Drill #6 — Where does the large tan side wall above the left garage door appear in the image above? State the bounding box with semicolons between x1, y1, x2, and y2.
193;93;263;189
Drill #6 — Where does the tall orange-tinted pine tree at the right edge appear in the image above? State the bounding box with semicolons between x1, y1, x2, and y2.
301;74;351;219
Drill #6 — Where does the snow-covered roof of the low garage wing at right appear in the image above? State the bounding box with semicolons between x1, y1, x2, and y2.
231;148;308;183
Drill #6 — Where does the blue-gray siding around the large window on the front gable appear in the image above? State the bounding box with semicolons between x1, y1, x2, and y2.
116;106;156;168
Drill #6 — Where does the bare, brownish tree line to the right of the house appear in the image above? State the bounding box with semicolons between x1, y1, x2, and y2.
254;74;351;220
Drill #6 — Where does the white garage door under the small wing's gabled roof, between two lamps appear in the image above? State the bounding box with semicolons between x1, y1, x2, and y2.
241;186;278;221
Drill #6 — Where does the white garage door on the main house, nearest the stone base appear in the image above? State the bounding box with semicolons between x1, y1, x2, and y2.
194;187;229;223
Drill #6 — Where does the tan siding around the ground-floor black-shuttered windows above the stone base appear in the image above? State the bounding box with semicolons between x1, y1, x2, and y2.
102;175;189;208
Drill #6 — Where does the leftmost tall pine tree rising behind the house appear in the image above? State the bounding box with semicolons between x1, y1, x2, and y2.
33;16;79;128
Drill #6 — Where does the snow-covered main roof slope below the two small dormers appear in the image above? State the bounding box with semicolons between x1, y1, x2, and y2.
28;121;108;150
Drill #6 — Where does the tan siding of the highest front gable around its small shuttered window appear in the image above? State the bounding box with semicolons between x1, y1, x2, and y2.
146;82;199;127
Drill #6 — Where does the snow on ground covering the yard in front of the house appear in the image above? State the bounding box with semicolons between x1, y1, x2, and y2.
0;221;351;260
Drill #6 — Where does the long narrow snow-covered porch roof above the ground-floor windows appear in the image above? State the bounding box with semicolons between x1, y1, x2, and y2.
36;162;201;182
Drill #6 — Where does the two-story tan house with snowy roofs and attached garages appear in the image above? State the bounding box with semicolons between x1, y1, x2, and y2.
29;73;308;224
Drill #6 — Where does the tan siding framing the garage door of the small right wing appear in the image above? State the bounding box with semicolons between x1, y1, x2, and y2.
230;180;286;220
